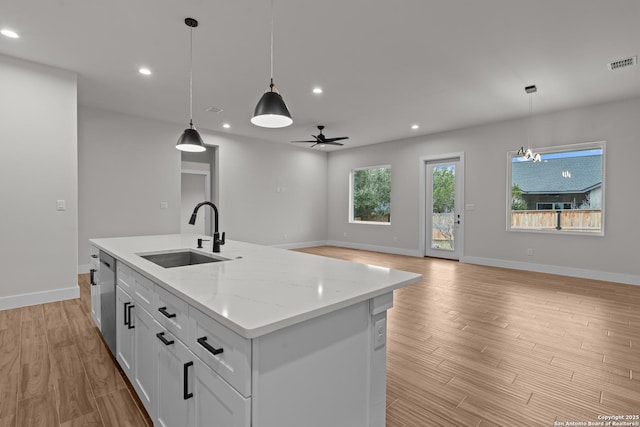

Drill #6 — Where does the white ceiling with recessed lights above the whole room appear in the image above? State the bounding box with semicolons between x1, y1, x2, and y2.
0;0;640;150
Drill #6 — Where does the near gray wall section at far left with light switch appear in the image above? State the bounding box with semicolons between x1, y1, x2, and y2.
0;55;78;309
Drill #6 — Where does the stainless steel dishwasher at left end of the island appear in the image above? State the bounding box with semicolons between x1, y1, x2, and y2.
98;251;116;357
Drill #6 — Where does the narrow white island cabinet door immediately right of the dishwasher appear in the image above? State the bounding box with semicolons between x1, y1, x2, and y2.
116;286;135;383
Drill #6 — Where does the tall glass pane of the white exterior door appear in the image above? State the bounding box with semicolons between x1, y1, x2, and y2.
431;164;456;251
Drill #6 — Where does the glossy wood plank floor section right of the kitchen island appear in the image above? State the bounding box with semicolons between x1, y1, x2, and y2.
300;247;640;427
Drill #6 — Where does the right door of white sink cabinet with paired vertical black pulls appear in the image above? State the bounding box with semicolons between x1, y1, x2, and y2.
133;301;162;419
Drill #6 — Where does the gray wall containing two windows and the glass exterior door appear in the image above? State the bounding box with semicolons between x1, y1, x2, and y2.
328;99;640;284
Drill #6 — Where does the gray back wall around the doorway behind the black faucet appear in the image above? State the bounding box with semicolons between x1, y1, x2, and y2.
78;106;327;269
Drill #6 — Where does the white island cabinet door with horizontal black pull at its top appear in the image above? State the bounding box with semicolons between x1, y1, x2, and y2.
156;328;195;427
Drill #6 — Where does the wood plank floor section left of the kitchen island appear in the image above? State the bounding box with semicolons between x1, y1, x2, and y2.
0;275;152;427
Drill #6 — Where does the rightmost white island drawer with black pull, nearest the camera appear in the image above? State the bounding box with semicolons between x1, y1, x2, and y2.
189;306;251;397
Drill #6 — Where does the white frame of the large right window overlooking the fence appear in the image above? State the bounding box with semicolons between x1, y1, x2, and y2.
505;141;607;237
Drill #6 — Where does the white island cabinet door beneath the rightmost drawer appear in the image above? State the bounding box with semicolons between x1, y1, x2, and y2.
193;357;251;427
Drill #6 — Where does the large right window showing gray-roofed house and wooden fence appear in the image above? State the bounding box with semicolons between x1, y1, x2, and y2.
507;142;605;236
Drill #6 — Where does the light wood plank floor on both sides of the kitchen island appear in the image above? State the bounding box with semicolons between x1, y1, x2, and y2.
0;247;640;427
